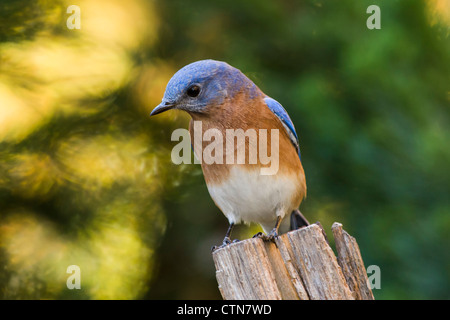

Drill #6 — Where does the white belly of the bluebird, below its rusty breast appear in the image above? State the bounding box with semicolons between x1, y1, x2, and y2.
208;166;299;232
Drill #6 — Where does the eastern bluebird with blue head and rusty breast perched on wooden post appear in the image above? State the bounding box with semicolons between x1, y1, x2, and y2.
150;60;309;246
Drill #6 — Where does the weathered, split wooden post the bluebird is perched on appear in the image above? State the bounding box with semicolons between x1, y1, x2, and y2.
213;223;373;300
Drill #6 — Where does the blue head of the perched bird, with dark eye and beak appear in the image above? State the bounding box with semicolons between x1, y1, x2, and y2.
150;60;256;116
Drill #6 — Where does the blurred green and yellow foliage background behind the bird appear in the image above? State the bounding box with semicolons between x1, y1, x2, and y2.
0;0;450;299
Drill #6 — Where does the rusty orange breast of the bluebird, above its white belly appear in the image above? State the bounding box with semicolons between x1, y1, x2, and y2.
189;92;306;205
